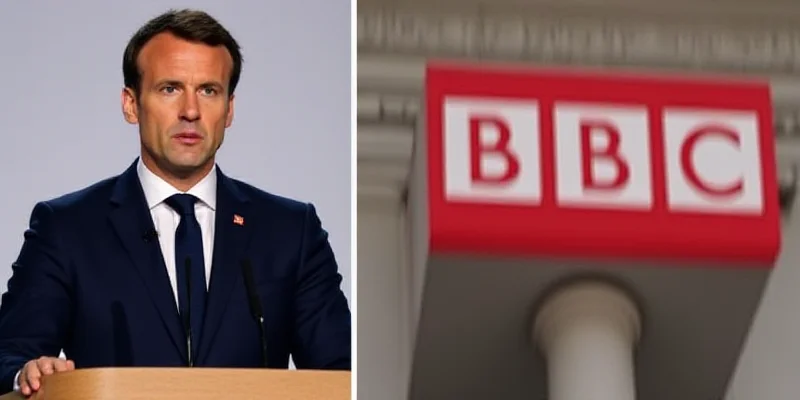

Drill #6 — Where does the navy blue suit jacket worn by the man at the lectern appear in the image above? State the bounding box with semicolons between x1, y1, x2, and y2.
0;162;351;393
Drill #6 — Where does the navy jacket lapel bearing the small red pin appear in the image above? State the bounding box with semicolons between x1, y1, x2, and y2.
198;168;252;362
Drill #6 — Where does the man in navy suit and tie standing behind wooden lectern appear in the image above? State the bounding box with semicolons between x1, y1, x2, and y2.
0;10;351;395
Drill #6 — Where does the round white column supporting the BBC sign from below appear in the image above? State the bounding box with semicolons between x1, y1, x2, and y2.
533;281;641;400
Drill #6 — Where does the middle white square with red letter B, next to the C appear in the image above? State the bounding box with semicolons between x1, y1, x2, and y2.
553;103;653;209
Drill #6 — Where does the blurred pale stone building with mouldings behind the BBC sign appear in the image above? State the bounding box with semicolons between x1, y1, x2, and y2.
357;0;800;400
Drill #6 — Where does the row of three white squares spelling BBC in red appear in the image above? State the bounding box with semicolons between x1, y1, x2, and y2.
443;96;763;213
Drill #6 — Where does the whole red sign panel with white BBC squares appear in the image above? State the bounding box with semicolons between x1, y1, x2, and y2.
426;61;780;266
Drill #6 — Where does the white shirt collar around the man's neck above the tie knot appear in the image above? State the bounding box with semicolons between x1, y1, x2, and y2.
136;158;217;210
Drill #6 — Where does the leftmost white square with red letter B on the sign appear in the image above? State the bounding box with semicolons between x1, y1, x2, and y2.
443;97;541;204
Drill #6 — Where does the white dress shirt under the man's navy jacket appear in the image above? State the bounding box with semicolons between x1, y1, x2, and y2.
14;158;217;392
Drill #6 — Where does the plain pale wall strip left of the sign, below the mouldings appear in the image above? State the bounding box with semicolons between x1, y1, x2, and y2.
357;196;411;400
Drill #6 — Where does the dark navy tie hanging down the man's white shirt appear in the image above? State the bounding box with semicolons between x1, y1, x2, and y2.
165;194;206;354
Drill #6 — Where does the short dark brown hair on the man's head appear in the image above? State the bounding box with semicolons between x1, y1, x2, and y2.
122;9;242;97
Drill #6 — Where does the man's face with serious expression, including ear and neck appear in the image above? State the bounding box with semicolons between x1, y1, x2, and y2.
122;33;233;179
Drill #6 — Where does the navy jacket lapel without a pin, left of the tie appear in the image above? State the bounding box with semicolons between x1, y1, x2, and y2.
109;162;186;357
